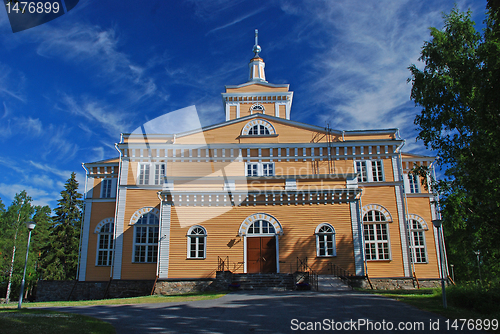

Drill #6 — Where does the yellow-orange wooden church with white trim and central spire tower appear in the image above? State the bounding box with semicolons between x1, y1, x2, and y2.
79;32;446;288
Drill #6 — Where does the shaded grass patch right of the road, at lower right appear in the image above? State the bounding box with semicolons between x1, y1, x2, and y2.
356;286;500;333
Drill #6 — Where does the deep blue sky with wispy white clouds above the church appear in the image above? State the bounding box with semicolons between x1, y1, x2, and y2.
0;0;486;208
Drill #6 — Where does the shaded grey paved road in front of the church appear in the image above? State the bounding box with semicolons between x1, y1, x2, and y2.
41;291;486;334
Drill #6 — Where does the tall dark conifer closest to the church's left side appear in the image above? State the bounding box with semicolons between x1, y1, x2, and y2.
40;173;83;280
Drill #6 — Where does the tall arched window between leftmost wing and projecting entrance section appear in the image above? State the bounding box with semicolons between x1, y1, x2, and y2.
133;212;159;263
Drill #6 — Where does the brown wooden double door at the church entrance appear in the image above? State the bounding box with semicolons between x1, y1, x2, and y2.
247;236;277;273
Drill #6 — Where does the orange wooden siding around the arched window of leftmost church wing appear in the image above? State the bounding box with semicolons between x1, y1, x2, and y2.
85;202;115;281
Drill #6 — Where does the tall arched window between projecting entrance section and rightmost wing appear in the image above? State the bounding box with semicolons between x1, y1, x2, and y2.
363;210;390;260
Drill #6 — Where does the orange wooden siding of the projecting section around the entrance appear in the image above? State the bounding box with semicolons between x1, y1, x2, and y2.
169;204;354;278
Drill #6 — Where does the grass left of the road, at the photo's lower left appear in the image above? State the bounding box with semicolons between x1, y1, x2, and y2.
0;292;226;334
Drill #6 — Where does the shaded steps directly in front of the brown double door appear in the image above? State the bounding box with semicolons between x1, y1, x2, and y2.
231;273;295;291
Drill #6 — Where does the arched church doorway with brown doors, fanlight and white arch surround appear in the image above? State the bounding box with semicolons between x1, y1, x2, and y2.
239;213;283;273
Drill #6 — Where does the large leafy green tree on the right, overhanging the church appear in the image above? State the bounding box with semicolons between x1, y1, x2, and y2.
409;4;500;278
